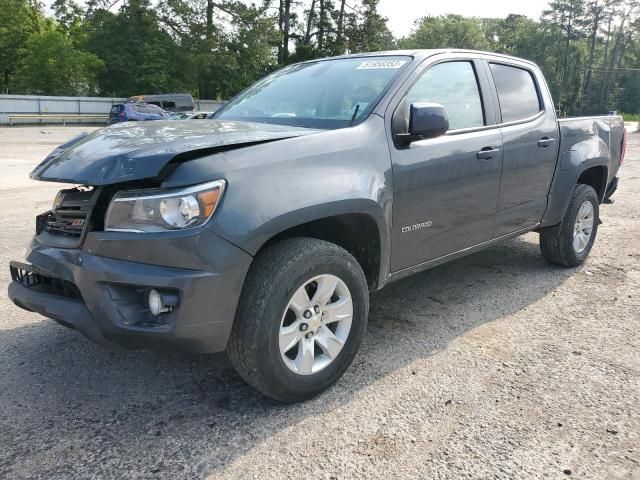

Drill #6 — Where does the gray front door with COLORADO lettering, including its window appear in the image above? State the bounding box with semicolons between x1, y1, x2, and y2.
391;58;502;272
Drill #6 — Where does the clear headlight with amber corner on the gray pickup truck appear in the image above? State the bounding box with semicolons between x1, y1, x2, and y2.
105;180;226;232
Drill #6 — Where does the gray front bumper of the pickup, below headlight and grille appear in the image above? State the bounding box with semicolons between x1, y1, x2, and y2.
8;228;252;352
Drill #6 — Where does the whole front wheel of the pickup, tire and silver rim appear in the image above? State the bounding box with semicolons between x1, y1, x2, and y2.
227;238;369;402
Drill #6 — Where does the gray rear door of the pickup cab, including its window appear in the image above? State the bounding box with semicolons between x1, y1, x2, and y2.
486;61;559;237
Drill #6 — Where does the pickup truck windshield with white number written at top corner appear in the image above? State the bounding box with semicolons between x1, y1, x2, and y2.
215;56;411;129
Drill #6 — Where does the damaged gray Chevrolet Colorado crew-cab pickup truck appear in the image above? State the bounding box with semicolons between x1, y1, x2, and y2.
9;50;625;402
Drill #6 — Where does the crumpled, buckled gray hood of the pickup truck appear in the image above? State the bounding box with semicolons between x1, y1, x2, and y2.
30;120;318;185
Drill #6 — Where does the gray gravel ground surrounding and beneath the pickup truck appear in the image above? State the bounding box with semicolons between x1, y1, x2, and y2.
0;127;640;479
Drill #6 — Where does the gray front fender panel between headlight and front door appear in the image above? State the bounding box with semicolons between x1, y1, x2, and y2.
166;115;393;272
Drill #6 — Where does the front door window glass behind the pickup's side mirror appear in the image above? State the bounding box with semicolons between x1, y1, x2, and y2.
406;61;485;130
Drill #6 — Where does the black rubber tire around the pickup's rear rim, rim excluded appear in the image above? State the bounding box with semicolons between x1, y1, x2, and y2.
540;184;600;267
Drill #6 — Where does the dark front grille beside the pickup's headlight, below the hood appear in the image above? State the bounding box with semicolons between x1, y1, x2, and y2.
36;187;100;248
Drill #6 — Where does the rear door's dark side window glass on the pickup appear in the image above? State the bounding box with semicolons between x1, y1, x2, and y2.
491;63;542;123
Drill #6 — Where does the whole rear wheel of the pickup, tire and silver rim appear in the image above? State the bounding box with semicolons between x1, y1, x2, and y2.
540;184;600;267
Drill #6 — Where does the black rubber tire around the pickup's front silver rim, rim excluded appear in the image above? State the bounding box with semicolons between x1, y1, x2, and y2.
227;238;369;403
